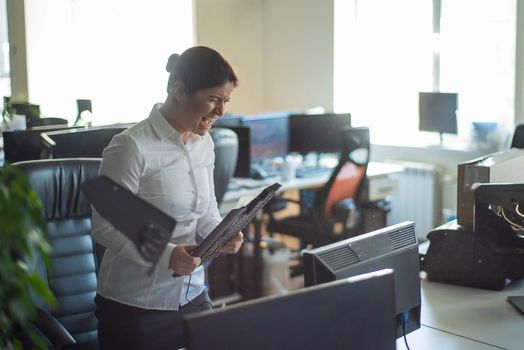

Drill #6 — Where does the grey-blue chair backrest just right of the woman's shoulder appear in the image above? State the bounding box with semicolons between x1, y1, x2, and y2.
209;128;238;205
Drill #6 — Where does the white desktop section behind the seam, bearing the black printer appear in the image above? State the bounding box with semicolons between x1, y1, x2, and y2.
421;280;524;349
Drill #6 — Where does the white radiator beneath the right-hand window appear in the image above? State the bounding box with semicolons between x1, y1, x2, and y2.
388;162;442;243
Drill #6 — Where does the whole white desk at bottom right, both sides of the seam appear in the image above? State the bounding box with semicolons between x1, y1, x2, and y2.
397;281;524;350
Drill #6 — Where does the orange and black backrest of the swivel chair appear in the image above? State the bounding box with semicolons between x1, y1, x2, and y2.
315;127;371;218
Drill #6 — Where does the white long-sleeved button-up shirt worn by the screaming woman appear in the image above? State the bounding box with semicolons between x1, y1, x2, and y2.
92;105;221;310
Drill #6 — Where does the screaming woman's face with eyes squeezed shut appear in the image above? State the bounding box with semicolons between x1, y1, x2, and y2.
177;82;235;136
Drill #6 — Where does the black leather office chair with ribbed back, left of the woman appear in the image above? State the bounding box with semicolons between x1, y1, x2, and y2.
12;159;103;349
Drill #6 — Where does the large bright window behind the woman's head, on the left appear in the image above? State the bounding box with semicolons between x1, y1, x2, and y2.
26;0;193;125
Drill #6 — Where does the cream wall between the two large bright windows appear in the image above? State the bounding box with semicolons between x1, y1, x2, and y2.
195;0;333;113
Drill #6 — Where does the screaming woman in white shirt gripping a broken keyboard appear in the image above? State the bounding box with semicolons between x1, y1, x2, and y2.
92;46;243;349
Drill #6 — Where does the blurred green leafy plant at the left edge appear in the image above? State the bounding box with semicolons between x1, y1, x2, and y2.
0;166;56;349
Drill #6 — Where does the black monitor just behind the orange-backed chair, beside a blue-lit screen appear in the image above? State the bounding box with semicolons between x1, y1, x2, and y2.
289;113;351;154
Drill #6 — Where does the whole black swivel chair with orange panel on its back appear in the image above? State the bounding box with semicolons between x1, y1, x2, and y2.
267;127;370;249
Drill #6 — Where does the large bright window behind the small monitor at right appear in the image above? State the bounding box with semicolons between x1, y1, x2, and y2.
334;0;516;143
